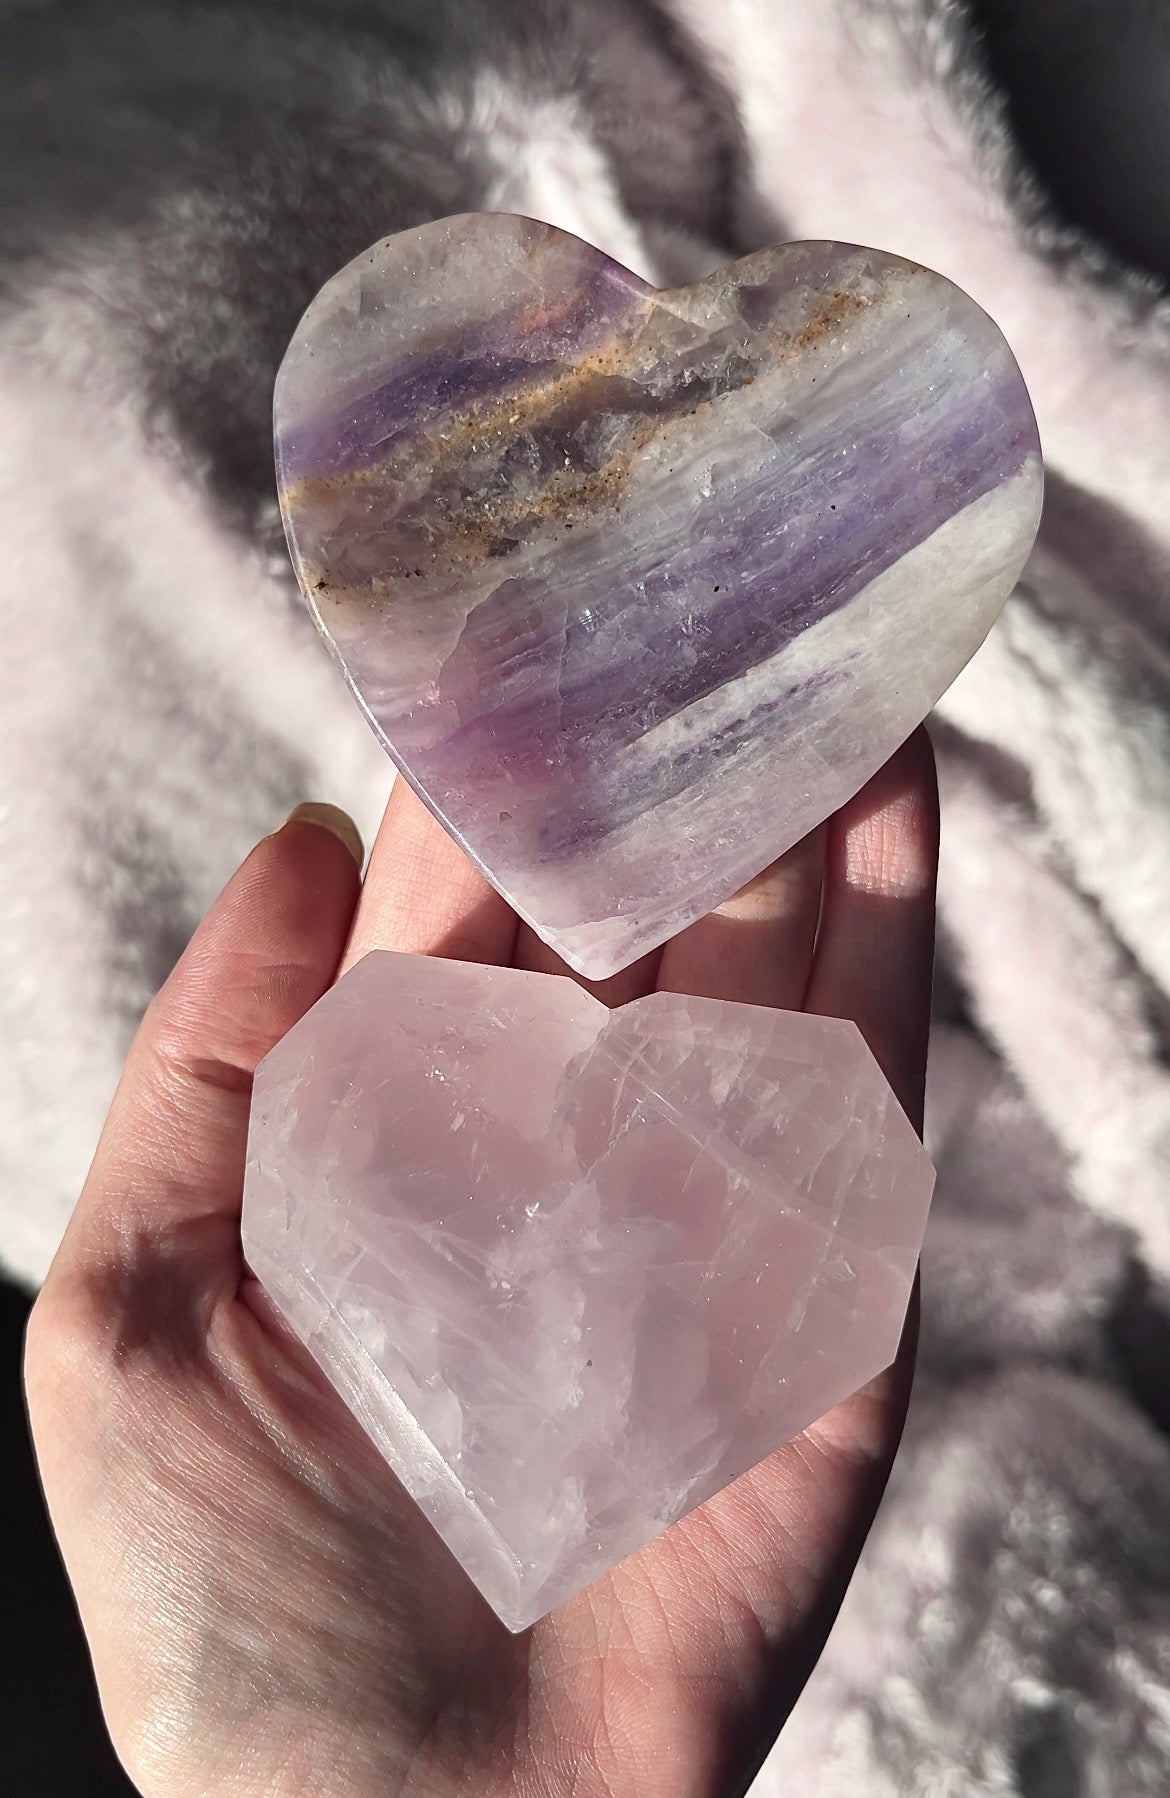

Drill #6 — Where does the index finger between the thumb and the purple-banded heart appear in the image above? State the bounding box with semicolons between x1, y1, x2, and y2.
341;779;516;973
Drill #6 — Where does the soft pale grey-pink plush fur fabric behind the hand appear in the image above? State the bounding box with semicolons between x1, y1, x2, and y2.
0;0;1170;1798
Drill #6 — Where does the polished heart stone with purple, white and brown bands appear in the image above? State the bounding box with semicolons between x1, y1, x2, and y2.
275;214;1042;976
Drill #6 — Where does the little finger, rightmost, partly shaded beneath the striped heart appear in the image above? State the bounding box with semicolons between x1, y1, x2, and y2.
805;728;938;1129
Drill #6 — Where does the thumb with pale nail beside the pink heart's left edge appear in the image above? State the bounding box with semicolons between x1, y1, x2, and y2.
51;806;361;1264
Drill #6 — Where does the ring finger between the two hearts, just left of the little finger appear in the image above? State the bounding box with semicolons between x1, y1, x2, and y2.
658;827;825;1010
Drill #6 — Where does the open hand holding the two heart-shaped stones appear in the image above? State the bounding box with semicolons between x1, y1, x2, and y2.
25;732;936;1798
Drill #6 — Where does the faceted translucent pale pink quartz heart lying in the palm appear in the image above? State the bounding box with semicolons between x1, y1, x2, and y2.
243;953;935;1629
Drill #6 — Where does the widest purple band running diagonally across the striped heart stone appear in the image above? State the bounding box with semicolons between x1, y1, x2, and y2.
435;361;1033;779
